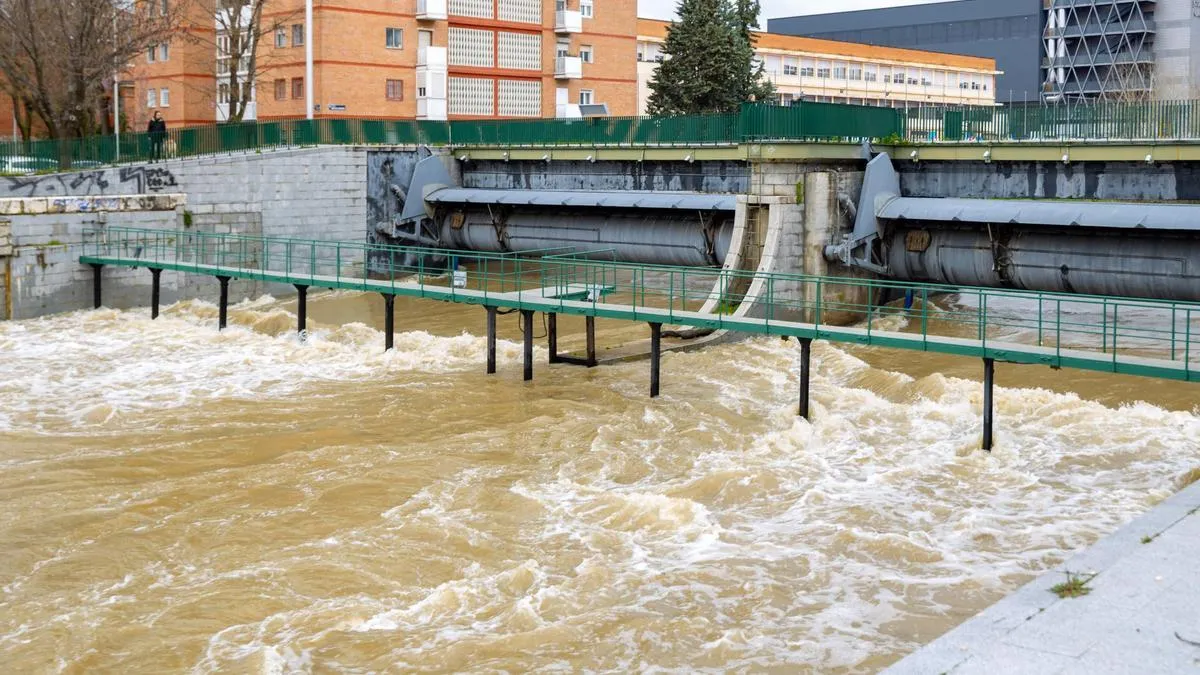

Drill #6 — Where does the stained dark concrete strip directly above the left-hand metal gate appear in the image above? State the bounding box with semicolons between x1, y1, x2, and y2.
462;160;750;193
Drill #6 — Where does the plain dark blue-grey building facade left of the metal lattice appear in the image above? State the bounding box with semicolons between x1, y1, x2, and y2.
767;0;1045;103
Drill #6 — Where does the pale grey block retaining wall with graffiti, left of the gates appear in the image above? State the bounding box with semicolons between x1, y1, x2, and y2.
0;147;432;318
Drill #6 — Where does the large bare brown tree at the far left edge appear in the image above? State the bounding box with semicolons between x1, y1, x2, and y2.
0;0;184;152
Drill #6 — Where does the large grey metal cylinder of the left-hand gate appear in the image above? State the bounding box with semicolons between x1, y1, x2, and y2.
440;209;733;267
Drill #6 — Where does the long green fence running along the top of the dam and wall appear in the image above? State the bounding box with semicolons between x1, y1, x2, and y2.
11;101;1200;174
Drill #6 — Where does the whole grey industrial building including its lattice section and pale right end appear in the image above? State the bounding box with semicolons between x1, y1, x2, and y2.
768;0;1200;103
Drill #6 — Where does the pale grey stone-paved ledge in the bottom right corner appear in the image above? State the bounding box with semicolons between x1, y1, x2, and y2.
884;473;1200;675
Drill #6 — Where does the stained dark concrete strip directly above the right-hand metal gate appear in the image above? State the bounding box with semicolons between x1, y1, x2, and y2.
896;161;1200;202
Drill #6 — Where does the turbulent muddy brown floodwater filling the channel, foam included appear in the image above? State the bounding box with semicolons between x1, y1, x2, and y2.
0;293;1200;673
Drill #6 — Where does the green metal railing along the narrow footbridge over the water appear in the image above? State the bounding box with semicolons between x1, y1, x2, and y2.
80;228;1200;382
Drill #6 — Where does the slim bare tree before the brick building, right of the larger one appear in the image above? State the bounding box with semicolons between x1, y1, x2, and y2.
190;0;300;123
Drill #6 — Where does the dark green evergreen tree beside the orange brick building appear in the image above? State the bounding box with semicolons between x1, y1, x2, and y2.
648;0;773;115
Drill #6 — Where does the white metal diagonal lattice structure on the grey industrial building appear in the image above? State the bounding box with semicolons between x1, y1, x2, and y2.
1042;0;1157;101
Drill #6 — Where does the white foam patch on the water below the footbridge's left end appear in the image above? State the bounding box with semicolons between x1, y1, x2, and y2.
0;297;530;434
